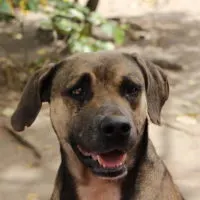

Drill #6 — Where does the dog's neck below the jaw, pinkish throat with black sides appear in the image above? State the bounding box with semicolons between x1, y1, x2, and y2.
51;121;148;200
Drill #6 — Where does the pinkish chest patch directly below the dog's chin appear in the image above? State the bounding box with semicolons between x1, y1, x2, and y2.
77;182;120;200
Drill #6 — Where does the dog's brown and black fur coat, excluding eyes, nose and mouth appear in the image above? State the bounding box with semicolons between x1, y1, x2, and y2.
11;52;183;200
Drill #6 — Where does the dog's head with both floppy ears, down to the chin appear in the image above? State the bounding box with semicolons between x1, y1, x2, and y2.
12;52;169;179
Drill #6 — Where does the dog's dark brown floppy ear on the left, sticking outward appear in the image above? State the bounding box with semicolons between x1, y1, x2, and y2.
11;64;58;131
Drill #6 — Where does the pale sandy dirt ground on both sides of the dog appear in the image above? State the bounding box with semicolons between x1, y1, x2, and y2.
0;0;200;200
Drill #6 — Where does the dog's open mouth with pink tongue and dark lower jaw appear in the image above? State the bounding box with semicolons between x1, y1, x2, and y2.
72;145;128;180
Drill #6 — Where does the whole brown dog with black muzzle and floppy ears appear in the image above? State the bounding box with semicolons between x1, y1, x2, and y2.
12;52;183;200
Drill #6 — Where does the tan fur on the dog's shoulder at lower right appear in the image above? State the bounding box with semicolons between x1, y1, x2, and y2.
132;140;183;200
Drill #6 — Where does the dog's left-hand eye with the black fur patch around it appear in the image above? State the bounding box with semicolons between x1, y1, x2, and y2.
61;74;92;103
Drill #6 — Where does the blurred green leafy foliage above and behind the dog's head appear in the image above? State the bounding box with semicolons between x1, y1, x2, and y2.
0;0;127;53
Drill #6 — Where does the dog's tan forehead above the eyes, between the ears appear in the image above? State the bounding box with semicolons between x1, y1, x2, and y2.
53;52;144;87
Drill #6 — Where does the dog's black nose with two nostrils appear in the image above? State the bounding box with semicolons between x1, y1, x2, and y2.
100;116;131;139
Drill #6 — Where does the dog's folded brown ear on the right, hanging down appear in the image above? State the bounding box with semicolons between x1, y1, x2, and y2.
124;54;169;125
